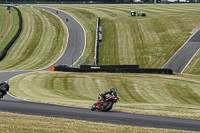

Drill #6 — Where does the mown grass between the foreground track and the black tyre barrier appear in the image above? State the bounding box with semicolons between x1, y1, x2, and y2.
9;72;200;119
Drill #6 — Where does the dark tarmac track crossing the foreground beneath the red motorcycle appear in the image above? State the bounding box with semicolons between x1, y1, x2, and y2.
0;100;200;131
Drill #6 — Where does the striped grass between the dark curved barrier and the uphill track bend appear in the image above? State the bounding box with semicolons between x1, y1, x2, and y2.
0;7;67;71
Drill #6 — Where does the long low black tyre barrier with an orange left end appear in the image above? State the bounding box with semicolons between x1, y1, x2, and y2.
50;65;173;75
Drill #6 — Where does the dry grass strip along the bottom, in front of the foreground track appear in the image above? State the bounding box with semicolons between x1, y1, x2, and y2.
0;112;194;133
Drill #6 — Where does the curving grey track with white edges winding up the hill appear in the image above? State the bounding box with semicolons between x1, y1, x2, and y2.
37;7;86;66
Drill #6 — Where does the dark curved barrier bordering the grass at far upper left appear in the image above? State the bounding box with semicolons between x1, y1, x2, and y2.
0;7;23;61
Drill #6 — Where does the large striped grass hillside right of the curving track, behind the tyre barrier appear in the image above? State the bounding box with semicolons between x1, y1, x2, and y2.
40;4;200;74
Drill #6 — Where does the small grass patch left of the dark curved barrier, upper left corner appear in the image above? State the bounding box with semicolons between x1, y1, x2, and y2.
0;6;19;54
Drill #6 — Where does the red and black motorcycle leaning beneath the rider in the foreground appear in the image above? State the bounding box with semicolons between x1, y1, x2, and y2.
91;95;119;111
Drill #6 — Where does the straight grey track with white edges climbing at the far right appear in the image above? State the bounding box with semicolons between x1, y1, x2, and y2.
162;29;200;73
